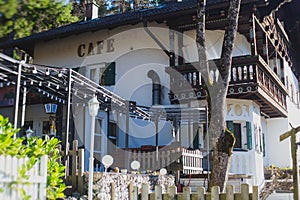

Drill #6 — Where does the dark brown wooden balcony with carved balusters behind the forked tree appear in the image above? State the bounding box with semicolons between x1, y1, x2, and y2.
166;56;288;118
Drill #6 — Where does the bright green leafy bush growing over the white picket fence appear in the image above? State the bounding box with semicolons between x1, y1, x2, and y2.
0;115;66;199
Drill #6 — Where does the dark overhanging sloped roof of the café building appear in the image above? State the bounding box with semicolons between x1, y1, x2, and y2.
0;0;267;52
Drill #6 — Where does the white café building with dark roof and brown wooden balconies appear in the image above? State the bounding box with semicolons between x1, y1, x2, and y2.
0;0;300;191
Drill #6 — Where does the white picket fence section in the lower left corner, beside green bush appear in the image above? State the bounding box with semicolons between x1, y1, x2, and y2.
0;155;48;200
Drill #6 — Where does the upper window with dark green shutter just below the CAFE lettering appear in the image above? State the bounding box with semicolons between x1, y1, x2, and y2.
87;62;116;86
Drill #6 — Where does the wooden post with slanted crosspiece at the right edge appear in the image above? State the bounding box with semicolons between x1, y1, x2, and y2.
279;124;300;199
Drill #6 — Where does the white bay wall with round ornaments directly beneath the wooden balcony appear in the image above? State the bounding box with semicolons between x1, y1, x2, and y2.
226;99;264;186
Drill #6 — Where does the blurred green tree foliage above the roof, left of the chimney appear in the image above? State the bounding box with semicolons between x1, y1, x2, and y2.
0;0;78;39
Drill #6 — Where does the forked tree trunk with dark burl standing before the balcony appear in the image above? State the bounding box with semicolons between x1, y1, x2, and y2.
196;0;241;191
